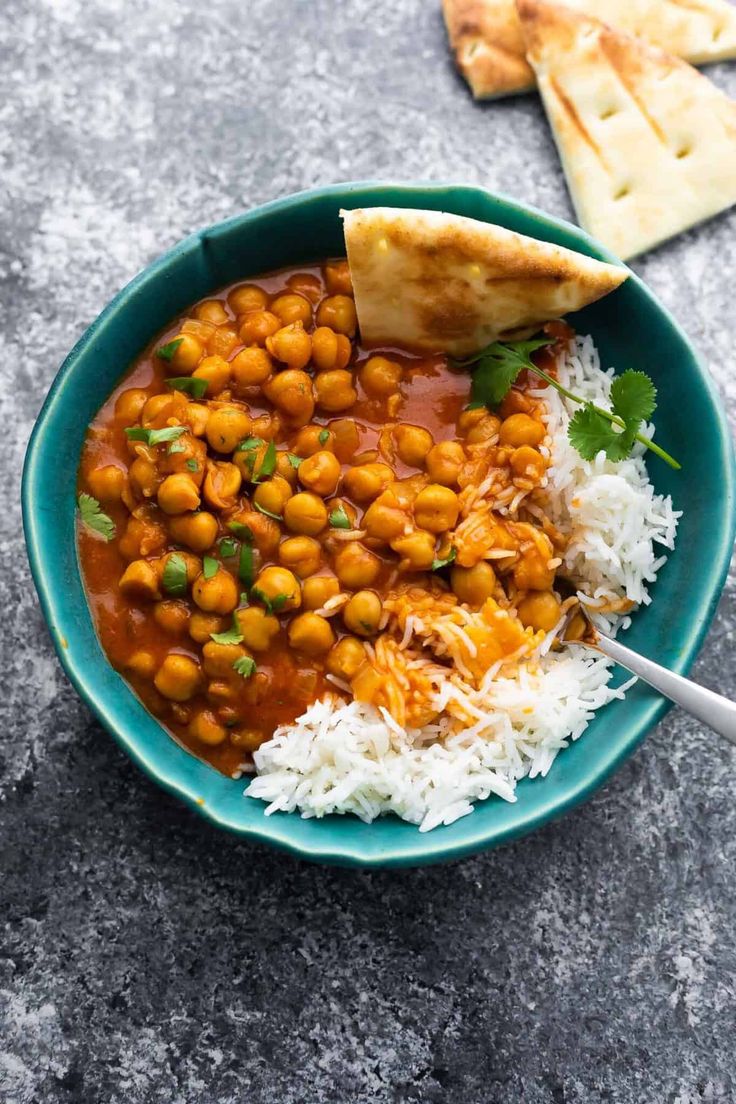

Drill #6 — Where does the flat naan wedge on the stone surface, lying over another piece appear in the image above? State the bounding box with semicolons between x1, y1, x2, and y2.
519;0;736;257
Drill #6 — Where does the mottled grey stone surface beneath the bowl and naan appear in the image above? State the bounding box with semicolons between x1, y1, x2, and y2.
0;0;736;1104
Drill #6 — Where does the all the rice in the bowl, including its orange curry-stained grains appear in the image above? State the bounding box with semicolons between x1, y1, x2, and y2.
246;338;680;831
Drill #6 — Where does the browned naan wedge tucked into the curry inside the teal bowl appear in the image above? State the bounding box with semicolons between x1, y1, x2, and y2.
341;208;628;357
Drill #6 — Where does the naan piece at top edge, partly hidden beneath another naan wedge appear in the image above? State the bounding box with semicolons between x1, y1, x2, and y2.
442;0;736;99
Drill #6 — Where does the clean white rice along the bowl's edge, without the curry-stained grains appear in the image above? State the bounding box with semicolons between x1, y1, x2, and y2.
246;338;680;831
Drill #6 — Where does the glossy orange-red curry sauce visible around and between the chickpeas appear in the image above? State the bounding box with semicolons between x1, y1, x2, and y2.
77;259;564;775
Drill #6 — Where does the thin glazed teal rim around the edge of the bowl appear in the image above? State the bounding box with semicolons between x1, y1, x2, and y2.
21;180;736;868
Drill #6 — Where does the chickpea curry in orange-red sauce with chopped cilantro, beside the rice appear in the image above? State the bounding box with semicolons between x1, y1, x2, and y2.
78;261;572;776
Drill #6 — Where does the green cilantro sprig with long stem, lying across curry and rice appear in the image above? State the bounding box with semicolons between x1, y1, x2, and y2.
454;338;681;470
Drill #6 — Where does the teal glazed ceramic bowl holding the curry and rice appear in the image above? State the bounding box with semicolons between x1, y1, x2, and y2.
22;183;736;867
